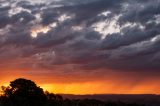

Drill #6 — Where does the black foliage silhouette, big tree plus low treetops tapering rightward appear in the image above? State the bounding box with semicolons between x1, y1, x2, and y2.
0;78;144;106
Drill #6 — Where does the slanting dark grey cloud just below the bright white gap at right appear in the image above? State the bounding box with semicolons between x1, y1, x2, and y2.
101;25;160;49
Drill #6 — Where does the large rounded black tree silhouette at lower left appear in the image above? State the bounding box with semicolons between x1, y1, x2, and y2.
2;78;47;106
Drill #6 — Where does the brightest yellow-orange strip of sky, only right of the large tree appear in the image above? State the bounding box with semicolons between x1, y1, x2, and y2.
38;82;160;95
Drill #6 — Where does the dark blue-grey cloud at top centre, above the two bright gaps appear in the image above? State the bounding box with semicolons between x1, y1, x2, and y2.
42;0;123;24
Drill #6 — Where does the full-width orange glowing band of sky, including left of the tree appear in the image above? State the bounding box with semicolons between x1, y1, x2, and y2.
0;71;160;95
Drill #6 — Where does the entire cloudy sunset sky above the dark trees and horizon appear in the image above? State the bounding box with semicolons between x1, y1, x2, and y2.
0;0;160;94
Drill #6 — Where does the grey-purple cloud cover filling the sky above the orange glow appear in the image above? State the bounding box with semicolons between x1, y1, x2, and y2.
0;0;160;78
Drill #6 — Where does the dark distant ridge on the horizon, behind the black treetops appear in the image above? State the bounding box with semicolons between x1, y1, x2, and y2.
61;94;160;106
